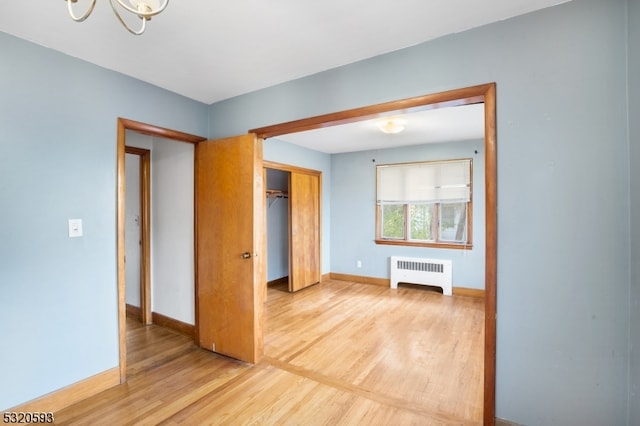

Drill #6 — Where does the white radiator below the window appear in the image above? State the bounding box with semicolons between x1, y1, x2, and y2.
391;256;452;296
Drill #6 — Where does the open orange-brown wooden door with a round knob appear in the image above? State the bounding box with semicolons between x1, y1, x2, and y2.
195;134;266;363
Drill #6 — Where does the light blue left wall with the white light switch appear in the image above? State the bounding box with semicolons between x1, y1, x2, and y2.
0;33;208;409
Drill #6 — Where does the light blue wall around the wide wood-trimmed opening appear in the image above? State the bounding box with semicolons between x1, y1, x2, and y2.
210;0;637;425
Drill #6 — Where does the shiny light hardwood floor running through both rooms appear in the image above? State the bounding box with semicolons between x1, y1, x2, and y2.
56;280;484;425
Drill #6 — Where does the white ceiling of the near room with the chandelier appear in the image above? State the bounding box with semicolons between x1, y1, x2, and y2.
0;0;564;152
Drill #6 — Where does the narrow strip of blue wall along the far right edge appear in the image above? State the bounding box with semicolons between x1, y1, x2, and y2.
629;0;640;425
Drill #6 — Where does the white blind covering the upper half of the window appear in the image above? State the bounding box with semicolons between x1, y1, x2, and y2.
376;159;471;204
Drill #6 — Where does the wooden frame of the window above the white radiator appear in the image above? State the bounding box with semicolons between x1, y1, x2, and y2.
375;158;473;250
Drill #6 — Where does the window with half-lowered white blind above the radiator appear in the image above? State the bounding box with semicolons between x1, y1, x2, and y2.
376;159;472;248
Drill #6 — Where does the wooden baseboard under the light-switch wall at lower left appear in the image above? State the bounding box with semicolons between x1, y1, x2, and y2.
6;367;120;413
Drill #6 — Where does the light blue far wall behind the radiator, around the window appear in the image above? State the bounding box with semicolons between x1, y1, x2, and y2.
331;140;485;289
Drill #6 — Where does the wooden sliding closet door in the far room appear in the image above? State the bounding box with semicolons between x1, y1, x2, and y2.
289;172;321;292
